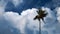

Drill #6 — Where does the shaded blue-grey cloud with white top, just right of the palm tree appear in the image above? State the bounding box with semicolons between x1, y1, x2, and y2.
41;8;57;34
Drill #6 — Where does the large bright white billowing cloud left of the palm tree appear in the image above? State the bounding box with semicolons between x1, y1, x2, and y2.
4;8;39;34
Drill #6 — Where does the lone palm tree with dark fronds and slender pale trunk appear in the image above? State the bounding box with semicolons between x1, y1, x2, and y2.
34;9;48;33
